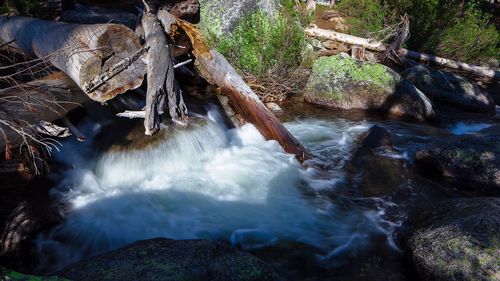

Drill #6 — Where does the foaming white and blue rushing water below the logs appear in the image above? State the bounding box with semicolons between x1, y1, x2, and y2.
38;112;396;270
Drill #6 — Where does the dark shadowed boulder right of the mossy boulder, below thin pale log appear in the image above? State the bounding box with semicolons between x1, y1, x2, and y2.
402;65;495;115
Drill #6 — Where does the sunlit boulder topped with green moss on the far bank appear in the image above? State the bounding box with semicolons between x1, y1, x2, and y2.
305;55;436;121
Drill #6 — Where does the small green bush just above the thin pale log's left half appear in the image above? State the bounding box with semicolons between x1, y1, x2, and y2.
338;0;384;36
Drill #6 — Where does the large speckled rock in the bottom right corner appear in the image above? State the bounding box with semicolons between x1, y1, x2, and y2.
406;198;500;281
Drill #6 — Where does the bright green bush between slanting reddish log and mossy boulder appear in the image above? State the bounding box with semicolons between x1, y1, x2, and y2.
216;9;305;77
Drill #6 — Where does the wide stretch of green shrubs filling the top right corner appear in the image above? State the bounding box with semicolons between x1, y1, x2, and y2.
339;0;500;63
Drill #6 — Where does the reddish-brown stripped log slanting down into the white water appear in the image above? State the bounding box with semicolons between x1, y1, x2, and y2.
162;12;309;162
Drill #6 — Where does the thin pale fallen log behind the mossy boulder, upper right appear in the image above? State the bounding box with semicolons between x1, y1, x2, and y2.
305;25;500;80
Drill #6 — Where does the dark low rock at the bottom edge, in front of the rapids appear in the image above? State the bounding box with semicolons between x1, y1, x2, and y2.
56;238;276;281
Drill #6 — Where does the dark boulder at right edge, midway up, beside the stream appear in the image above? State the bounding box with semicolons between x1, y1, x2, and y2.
415;125;500;195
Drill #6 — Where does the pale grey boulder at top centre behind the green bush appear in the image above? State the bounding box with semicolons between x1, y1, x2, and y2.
199;0;280;37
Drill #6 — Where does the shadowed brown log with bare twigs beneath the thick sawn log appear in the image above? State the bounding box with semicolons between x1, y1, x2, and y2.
0;73;89;151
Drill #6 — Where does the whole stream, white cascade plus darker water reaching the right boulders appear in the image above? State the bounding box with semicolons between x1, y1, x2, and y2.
36;99;489;280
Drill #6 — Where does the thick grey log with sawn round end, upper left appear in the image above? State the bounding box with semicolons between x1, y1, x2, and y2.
0;16;146;102
